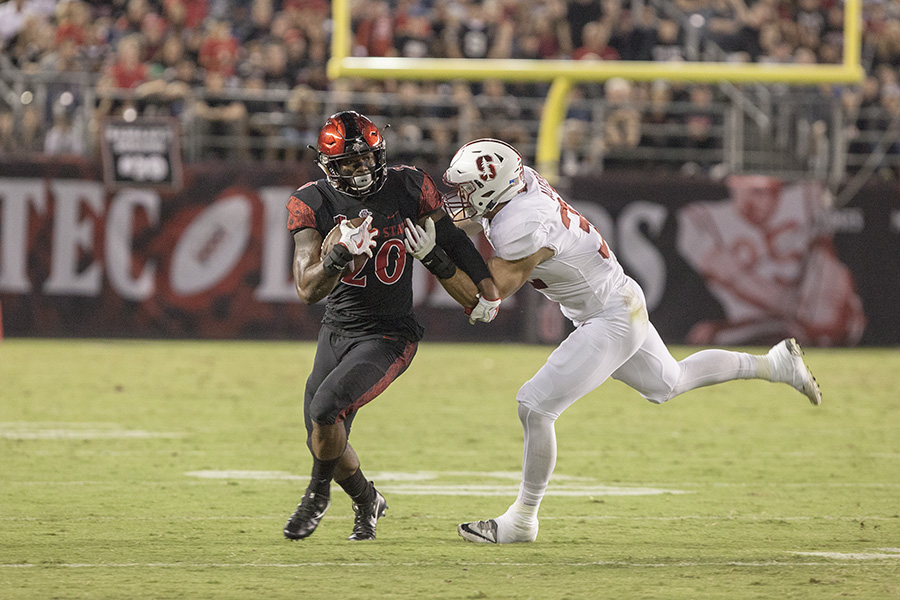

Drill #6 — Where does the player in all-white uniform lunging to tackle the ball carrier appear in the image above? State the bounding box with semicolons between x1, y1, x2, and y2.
413;139;822;544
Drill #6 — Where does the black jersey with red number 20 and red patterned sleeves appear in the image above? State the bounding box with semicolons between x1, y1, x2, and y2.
287;166;441;341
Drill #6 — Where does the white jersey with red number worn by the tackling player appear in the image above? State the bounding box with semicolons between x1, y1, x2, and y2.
482;167;628;325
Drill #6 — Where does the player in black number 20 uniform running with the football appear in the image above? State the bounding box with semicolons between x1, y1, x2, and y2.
284;111;500;540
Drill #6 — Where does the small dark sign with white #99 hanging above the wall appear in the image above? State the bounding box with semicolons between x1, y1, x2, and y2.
100;117;182;190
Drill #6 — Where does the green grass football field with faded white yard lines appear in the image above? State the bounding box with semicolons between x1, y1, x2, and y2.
0;339;900;600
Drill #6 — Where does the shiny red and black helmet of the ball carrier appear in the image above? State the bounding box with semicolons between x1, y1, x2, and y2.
316;110;387;198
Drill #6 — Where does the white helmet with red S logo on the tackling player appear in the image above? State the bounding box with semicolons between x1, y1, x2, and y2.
444;138;525;221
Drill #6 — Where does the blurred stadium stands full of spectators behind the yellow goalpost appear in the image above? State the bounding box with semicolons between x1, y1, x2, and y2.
0;0;900;180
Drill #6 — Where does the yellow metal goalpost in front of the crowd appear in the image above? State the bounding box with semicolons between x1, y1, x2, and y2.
328;0;865;178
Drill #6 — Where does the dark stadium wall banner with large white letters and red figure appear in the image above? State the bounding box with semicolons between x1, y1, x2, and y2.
0;160;900;346
